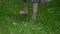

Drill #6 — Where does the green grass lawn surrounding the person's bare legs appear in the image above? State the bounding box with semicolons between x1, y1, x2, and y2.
0;0;60;34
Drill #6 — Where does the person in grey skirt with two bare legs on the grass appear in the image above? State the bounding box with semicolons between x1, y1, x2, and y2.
20;0;46;20
